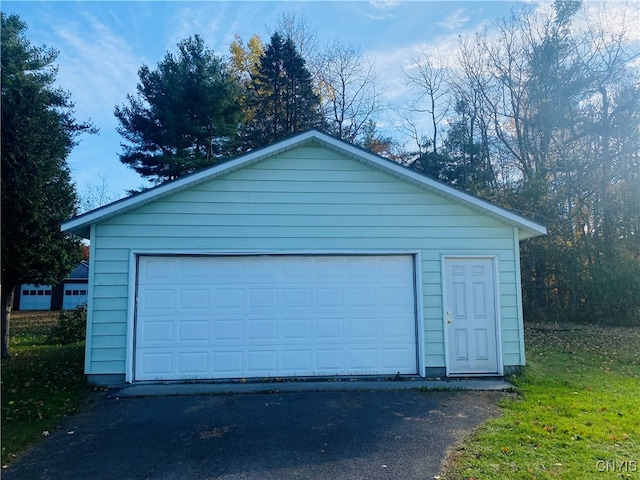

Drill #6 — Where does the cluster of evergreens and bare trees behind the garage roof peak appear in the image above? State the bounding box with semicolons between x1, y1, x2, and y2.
114;13;390;184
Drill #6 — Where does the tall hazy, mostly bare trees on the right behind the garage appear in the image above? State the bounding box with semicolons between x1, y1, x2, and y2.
408;1;640;323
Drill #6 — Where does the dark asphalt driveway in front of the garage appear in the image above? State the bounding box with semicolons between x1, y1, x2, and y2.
2;390;505;480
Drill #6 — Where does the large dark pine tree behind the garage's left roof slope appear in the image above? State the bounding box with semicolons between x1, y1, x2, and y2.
115;35;240;183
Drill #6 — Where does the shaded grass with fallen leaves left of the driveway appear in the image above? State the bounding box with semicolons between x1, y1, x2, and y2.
1;312;90;465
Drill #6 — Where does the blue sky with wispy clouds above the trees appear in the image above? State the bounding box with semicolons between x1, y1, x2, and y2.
1;0;544;197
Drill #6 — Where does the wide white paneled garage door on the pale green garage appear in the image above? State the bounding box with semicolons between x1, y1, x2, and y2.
134;255;417;381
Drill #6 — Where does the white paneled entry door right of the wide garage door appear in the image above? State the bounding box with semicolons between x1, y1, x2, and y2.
444;258;499;375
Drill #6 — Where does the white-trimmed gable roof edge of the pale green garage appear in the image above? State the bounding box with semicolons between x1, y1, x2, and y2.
61;130;547;240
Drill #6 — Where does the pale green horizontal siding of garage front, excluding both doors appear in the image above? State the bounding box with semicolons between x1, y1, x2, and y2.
86;144;524;375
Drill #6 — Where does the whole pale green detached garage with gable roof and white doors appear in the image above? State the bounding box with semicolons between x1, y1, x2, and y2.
62;131;545;384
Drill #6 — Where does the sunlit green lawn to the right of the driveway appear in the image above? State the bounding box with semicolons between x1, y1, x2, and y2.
441;324;640;480
